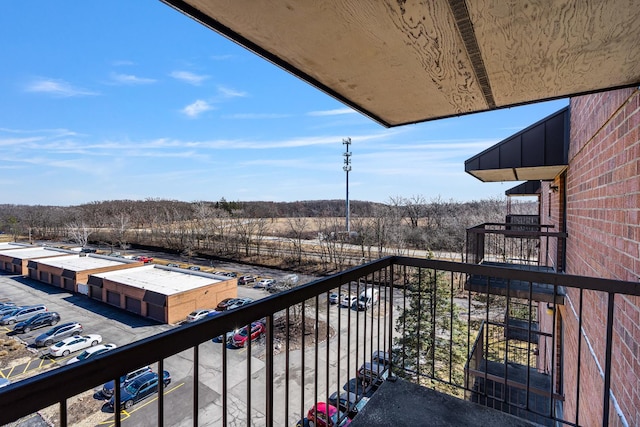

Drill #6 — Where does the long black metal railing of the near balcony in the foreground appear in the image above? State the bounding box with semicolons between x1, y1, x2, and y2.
0;257;640;426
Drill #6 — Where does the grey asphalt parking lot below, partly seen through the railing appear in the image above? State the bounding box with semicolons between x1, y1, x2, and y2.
0;266;392;427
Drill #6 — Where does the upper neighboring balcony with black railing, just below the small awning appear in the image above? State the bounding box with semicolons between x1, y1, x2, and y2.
465;224;566;305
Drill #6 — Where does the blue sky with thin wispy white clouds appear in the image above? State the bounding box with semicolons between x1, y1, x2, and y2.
0;0;568;205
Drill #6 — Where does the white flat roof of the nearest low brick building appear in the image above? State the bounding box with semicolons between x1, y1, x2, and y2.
92;265;228;295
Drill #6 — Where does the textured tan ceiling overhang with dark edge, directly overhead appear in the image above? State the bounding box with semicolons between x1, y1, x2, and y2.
161;0;640;126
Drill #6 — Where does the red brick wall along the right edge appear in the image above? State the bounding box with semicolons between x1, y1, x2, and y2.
562;89;640;425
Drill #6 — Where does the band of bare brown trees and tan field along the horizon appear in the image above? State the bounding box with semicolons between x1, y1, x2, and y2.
0;196;537;271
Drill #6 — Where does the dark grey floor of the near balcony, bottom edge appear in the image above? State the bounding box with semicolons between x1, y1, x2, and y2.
351;378;538;427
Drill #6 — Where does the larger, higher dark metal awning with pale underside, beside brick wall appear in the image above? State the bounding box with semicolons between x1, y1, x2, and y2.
464;107;569;182
